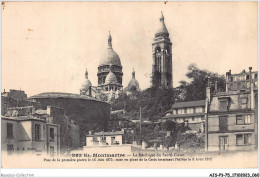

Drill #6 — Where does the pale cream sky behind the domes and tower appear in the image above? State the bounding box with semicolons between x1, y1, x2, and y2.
1;1;258;96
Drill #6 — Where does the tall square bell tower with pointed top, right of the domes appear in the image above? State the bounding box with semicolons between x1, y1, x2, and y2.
151;13;172;88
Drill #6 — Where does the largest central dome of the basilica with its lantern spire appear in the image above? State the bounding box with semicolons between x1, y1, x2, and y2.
99;33;121;66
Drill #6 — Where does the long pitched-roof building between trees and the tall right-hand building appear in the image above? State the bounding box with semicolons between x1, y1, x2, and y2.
161;100;206;132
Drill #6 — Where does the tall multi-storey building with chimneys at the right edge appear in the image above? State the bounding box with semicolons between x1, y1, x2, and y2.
205;68;258;151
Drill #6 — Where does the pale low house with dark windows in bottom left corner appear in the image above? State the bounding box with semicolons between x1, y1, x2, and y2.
1;107;60;156
